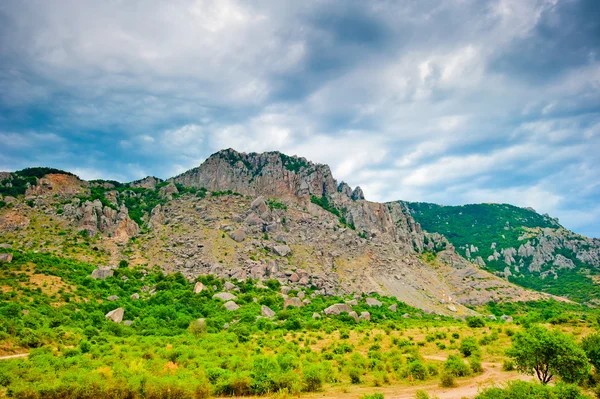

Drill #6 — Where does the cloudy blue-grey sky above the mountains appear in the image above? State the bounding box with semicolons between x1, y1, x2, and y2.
0;0;600;237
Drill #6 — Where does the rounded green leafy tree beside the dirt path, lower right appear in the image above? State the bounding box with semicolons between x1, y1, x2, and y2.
506;326;590;384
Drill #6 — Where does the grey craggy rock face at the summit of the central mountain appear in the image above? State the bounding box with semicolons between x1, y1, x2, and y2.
173;149;337;197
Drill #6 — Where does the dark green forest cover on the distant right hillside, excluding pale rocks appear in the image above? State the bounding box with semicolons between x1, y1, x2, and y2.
403;202;600;302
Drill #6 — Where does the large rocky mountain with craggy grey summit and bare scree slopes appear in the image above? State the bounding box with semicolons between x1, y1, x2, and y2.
0;149;568;315
